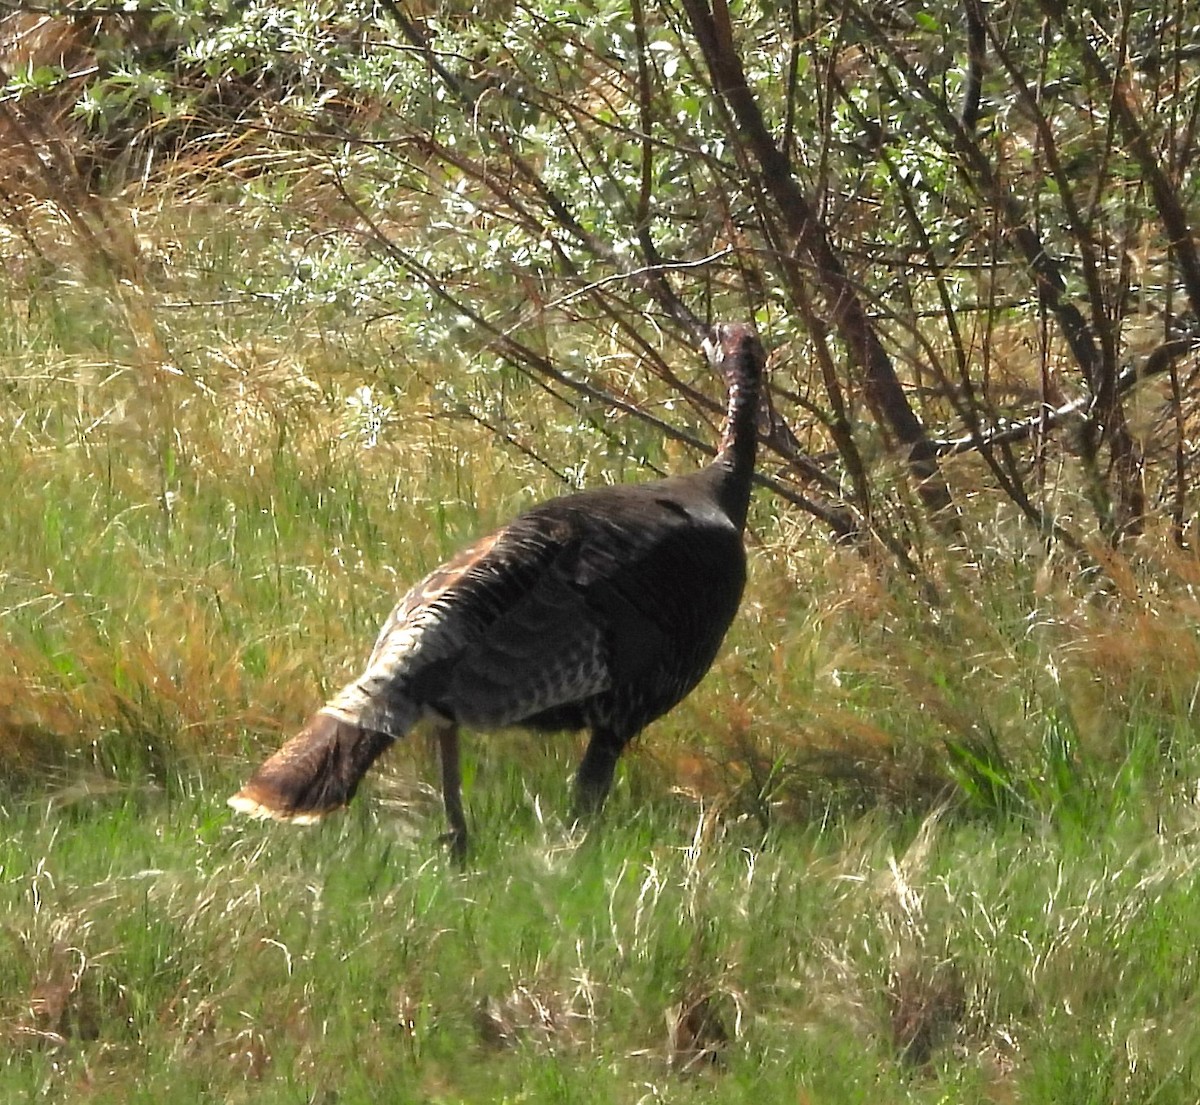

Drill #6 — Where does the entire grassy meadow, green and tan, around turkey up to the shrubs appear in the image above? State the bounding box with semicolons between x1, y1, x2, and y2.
7;196;1200;1105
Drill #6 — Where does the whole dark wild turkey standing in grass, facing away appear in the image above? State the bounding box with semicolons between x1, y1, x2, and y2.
229;324;764;859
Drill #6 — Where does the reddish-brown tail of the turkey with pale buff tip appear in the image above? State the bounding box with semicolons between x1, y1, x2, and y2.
229;711;392;824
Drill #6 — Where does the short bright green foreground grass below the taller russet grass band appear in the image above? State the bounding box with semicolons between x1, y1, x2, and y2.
7;773;1200;1103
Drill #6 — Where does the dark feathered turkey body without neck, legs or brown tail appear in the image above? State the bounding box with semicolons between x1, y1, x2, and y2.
355;473;745;758
